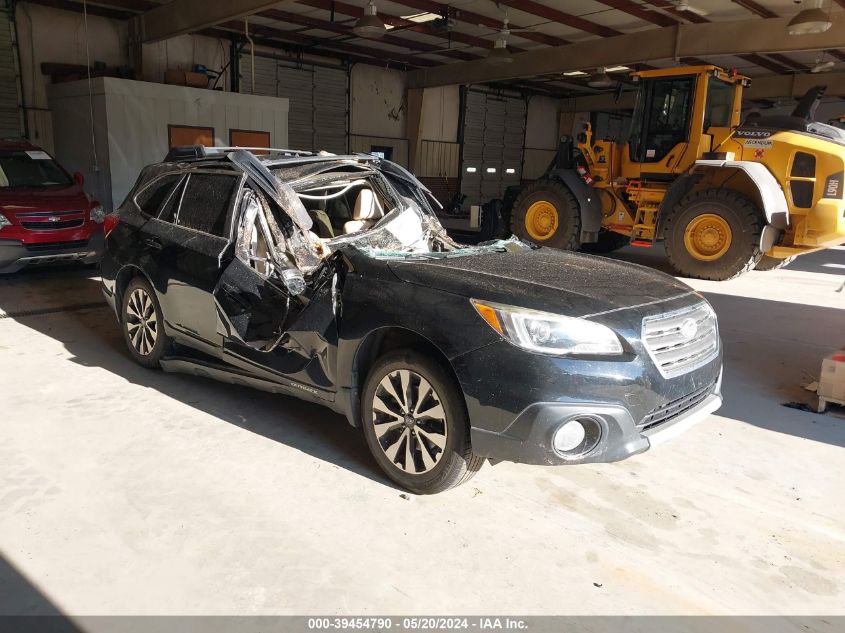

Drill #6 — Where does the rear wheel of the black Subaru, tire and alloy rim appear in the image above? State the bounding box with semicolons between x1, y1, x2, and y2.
120;277;172;368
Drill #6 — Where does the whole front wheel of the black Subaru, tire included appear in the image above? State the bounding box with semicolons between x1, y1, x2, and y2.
361;349;484;494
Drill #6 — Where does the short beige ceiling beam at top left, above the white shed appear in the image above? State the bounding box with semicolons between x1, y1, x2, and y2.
134;0;292;44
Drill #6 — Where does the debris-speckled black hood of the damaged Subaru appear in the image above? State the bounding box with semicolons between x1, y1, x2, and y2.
389;248;693;316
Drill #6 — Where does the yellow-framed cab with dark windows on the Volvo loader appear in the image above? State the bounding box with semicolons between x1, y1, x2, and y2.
622;66;745;181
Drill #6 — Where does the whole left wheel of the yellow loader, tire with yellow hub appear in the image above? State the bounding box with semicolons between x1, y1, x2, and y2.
511;180;581;251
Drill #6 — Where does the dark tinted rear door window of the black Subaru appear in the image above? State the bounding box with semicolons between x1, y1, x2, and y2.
176;174;240;237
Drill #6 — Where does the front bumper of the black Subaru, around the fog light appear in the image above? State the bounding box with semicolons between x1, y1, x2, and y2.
453;343;722;465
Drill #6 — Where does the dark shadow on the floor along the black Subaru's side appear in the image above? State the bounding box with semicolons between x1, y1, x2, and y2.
15;279;395;488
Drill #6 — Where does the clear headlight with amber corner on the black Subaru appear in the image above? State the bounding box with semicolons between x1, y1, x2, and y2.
471;299;622;356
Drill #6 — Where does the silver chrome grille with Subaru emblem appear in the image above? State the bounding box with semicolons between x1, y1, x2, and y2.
643;303;719;378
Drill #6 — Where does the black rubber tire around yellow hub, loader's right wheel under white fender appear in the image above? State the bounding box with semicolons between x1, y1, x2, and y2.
664;189;765;281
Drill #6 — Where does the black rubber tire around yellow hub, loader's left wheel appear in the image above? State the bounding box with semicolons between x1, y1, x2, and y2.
511;180;581;251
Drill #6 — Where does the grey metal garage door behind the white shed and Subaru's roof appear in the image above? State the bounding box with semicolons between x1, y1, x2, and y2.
240;55;349;154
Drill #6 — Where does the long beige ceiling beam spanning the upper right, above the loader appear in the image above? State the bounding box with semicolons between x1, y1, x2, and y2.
408;12;845;88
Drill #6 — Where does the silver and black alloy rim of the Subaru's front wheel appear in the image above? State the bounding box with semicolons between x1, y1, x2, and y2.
372;369;448;475
